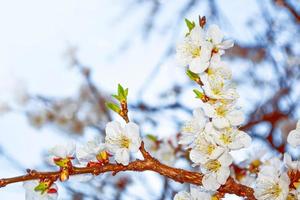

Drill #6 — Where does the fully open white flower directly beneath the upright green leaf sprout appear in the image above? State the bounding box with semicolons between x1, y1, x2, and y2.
105;121;141;165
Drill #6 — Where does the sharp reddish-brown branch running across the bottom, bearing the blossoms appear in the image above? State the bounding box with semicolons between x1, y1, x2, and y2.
0;143;255;200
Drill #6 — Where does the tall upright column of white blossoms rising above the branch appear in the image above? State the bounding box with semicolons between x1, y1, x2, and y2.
175;20;251;199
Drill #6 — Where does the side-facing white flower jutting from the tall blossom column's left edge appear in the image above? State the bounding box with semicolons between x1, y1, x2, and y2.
179;108;207;145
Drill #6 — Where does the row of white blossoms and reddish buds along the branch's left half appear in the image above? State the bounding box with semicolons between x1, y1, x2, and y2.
24;121;141;200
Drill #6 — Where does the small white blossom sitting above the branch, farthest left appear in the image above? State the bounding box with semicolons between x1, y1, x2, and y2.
48;143;76;167
